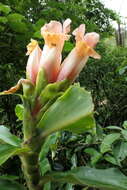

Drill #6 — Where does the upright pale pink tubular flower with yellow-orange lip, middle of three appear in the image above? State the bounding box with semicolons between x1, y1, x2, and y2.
40;19;71;82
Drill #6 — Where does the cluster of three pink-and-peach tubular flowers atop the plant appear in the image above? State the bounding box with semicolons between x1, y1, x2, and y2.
26;19;100;84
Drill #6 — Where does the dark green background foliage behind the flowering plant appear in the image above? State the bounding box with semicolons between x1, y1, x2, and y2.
0;0;127;190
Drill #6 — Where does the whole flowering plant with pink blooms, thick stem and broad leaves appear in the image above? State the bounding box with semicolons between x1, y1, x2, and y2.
0;19;127;190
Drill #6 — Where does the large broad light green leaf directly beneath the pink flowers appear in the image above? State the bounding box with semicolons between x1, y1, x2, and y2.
38;85;95;136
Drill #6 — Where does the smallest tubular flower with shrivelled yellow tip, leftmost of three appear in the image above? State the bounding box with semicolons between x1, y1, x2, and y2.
26;39;42;84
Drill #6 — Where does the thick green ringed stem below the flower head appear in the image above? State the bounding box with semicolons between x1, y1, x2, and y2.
20;100;43;190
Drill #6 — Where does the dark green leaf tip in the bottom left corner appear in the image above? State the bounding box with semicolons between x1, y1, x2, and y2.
0;179;26;190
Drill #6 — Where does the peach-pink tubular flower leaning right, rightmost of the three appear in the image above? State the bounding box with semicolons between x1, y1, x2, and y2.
57;24;100;82
